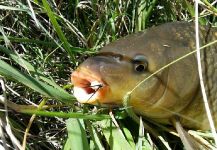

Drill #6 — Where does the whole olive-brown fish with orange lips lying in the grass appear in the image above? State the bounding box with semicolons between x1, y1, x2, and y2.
71;22;217;130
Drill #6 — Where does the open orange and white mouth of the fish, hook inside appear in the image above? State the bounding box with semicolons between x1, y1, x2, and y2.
71;69;108;104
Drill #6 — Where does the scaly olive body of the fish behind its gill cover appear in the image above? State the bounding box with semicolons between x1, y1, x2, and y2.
182;27;217;129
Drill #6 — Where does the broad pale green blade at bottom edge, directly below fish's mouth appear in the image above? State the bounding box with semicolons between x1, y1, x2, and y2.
64;118;89;150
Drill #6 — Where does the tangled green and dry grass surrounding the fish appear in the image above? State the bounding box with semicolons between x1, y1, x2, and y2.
0;0;217;150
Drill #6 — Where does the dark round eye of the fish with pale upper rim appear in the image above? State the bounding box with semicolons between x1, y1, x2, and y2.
133;55;148;73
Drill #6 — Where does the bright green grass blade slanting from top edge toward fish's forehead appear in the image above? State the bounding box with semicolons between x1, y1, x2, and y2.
42;0;75;60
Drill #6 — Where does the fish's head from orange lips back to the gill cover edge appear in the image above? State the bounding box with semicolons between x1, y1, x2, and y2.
71;22;197;118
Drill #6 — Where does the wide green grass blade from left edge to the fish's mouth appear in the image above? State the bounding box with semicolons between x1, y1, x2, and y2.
0;60;73;103
